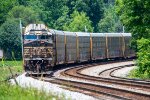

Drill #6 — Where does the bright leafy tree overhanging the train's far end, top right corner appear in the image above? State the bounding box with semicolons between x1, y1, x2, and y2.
116;0;150;49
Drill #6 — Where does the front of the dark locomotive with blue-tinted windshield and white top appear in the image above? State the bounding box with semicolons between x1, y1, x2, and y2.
23;24;53;73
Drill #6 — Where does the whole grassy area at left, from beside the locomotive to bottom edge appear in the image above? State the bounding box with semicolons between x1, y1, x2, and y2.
0;60;64;100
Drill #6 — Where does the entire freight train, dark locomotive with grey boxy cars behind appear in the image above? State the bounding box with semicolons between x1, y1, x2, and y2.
22;24;135;73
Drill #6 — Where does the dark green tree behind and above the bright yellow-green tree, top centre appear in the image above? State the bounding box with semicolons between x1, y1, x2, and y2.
67;0;104;32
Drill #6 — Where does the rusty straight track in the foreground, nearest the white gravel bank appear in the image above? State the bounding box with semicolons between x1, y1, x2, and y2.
31;77;150;100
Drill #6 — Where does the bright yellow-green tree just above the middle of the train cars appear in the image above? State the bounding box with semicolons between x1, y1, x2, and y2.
64;11;93;32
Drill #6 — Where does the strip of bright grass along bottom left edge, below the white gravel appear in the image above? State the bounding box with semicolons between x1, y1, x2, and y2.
0;84;61;100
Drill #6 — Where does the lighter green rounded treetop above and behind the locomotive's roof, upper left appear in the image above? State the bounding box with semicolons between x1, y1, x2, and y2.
7;6;40;26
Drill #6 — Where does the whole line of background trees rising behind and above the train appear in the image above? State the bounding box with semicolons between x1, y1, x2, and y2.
0;0;120;32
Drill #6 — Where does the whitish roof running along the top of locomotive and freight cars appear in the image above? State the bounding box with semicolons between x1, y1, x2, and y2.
24;24;131;37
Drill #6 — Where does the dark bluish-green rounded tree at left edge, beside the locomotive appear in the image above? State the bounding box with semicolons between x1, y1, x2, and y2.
0;19;21;57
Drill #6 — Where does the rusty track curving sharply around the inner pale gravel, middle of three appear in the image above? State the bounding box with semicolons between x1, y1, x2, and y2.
61;65;150;92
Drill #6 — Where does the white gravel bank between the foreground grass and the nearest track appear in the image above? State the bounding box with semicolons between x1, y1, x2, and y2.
10;73;96;100
